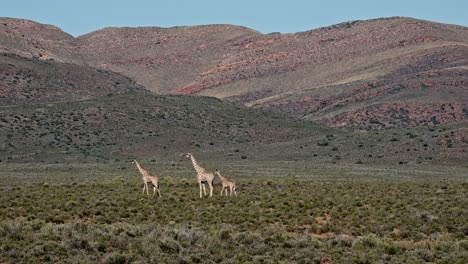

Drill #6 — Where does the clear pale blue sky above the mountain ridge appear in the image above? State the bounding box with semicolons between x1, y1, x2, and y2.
0;0;468;36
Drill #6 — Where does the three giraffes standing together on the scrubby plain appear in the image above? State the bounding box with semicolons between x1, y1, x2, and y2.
132;153;237;198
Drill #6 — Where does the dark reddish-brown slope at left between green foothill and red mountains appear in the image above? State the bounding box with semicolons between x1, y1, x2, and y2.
0;53;146;106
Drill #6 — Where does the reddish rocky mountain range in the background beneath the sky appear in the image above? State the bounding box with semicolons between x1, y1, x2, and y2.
0;17;468;129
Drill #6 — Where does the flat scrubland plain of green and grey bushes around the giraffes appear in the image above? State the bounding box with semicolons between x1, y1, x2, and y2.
0;159;468;263
